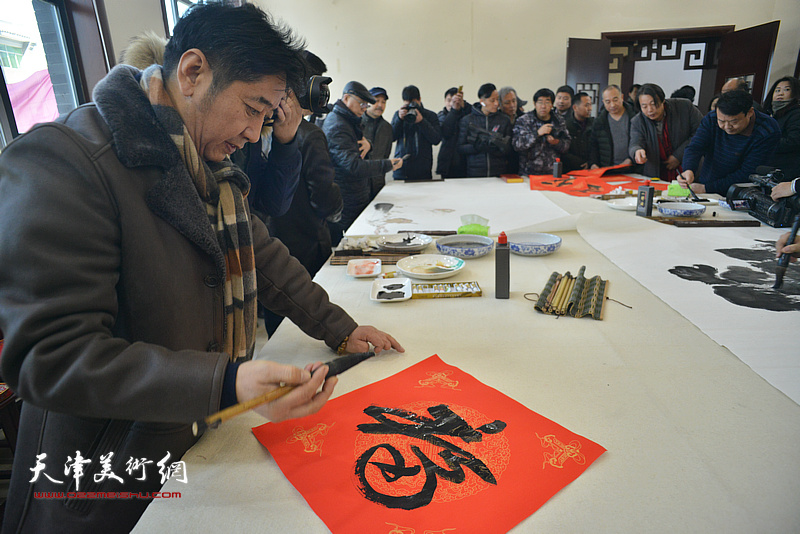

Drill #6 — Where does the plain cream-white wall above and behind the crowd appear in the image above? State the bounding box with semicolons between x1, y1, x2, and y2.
105;0;800;117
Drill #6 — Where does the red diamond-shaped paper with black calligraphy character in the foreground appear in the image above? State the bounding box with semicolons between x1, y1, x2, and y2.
253;355;605;533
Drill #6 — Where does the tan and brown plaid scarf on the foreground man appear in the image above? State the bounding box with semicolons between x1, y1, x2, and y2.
139;65;257;361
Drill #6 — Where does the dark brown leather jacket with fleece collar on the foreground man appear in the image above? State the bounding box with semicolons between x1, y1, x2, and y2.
0;66;356;532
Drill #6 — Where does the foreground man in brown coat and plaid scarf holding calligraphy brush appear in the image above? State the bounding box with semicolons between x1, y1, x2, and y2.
0;3;402;532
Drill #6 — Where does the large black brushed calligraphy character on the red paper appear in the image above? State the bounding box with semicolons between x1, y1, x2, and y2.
355;404;506;510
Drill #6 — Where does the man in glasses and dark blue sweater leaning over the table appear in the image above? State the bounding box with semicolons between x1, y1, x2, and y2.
678;91;781;196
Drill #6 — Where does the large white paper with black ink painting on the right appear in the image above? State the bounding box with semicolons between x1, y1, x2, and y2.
578;212;800;404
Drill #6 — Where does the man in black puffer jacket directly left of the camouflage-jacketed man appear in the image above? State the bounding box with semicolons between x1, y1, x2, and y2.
458;83;511;177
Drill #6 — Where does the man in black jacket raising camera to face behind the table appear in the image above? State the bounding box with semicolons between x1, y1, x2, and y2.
392;85;442;180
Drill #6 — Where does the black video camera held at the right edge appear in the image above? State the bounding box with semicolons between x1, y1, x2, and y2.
725;166;800;228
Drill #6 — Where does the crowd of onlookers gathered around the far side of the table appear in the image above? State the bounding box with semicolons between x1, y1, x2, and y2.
260;67;800;296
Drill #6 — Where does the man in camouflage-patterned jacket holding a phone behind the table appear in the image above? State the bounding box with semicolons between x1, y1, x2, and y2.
513;88;571;175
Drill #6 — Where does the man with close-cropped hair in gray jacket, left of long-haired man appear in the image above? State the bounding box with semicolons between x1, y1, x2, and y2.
589;85;636;169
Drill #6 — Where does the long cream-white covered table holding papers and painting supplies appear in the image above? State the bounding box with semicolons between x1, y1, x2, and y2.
135;180;800;534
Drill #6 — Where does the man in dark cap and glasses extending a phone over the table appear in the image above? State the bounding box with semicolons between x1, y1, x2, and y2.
322;81;403;246
